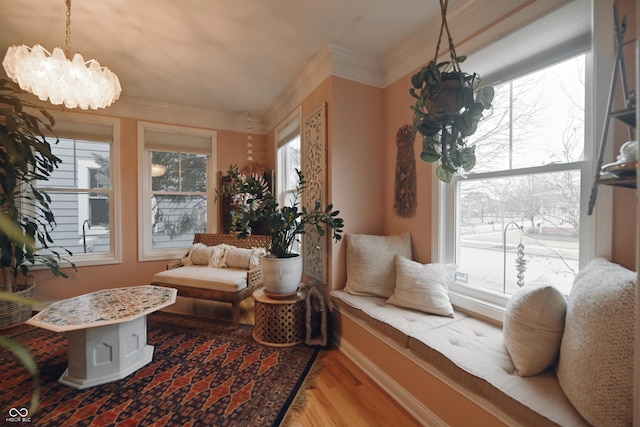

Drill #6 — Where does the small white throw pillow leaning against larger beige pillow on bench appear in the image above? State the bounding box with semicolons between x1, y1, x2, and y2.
387;255;456;317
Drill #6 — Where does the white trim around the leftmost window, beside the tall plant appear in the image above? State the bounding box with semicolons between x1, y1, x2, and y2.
46;112;122;267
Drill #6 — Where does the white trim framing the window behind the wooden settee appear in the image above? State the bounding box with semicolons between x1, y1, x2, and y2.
138;122;218;262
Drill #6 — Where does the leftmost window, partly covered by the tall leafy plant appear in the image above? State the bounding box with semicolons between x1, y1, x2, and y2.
38;115;119;265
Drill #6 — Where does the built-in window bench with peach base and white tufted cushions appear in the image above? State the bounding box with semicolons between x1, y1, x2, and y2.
331;290;589;426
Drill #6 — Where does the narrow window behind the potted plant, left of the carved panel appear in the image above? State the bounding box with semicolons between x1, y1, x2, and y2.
276;110;302;253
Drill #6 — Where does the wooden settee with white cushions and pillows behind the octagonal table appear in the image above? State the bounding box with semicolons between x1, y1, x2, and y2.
153;233;271;328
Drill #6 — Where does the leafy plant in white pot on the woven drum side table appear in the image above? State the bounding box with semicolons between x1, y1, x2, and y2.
224;165;344;295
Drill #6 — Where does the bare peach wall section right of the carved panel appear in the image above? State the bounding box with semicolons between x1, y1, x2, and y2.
329;77;389;289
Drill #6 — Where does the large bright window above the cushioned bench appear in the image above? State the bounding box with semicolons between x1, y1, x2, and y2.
436;2;594;319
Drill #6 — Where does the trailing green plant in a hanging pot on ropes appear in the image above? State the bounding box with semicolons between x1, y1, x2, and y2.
409;0;494;182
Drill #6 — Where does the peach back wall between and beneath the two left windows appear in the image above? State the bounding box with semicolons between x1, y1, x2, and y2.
34;118;274;301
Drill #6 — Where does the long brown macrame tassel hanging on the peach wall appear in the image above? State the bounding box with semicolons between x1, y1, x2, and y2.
393;125;417;218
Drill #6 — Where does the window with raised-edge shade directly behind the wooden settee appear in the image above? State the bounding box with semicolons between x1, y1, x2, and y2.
139;124;217;260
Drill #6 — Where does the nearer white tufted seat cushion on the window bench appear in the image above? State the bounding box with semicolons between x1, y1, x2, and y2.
409;317;587;426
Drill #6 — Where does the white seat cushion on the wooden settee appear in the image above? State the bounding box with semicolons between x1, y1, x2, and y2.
153;265;247;292
